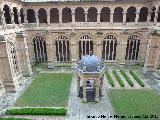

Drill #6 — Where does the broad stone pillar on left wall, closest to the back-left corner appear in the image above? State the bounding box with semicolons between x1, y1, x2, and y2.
16;32;32;76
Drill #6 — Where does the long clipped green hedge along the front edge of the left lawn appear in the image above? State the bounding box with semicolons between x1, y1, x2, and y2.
6;108;67;115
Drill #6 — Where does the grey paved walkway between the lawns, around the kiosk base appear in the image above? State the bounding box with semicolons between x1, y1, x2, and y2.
65;73;115;120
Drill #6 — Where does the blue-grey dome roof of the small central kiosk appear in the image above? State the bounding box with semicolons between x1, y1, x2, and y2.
78;55;104;72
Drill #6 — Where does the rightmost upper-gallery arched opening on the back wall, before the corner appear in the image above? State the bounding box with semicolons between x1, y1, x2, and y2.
139;7;148;22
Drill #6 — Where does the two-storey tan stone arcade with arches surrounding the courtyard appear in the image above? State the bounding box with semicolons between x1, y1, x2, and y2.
0;0;160;95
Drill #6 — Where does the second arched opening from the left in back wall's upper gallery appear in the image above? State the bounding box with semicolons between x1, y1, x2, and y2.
38;8;47;23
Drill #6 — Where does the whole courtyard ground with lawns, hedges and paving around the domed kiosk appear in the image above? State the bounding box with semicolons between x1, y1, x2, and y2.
0;63;160;120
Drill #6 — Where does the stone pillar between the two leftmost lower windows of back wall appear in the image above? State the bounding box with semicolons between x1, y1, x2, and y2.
46;31;55;69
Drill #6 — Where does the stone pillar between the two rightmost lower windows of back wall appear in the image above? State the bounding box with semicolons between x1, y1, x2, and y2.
117;33;128;67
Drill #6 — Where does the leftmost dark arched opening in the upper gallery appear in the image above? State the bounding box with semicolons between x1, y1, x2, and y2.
3;5;11;24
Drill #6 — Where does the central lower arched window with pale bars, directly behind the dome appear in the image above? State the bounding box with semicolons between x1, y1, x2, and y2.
79;35;93;59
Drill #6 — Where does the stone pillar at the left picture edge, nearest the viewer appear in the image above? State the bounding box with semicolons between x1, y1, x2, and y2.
0;40;18;92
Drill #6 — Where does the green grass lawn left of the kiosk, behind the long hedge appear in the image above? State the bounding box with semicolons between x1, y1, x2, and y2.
15;73;72;107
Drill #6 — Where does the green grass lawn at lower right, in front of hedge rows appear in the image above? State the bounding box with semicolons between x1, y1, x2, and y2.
109;90;160;120
